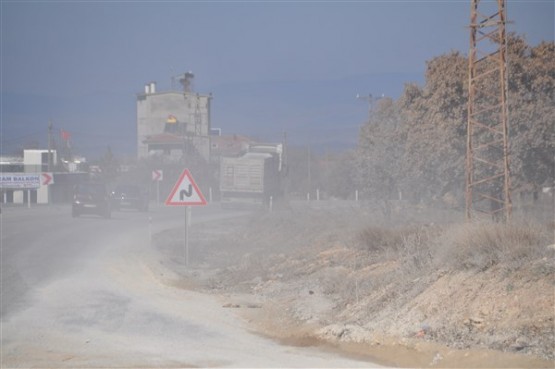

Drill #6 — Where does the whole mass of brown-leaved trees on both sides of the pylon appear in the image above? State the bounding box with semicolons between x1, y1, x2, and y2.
356;34;555;211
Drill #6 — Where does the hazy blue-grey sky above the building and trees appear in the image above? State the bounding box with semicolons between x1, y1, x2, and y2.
1;0;555;156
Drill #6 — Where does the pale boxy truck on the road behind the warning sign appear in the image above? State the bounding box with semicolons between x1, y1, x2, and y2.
220;144;283;208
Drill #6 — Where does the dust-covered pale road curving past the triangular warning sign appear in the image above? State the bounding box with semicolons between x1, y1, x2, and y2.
0;205;377;368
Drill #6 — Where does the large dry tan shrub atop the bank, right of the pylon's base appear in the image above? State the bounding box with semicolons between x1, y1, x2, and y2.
434;218;552;270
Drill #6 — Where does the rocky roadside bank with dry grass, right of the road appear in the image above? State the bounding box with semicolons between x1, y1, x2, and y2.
156;204;555;367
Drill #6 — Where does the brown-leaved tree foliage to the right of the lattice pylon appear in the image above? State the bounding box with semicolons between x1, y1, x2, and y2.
508;35;555;190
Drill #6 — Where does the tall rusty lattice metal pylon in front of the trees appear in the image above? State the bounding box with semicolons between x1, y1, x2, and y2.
466;0;511;221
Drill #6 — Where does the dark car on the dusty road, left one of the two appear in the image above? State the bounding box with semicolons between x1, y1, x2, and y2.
71;182;112;218
